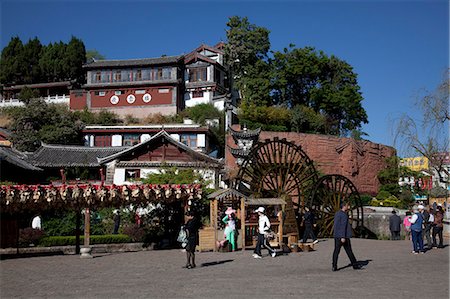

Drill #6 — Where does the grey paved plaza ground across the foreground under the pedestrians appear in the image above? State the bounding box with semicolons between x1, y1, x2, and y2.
0;239;449;299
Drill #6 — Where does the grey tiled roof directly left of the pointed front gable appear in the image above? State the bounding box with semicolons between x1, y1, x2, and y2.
28;144;127;167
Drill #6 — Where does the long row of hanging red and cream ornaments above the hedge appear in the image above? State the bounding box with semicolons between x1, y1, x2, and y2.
0;184;202;213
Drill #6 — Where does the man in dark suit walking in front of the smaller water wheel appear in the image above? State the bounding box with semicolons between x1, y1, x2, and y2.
332;202;362;271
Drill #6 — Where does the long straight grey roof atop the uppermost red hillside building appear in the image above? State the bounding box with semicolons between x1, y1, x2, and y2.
83;56;183;69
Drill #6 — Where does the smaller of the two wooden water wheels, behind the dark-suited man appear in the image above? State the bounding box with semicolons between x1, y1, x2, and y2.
307;174;363;237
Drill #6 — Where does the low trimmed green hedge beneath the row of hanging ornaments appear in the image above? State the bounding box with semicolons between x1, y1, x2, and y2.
38;235;132;247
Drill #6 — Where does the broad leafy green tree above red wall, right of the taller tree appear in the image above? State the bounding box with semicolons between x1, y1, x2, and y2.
273;47;368;135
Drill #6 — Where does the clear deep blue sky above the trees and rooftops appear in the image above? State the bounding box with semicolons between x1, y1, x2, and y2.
0;0;449;155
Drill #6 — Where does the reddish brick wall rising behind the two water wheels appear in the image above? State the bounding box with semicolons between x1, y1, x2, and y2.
225;125;396;195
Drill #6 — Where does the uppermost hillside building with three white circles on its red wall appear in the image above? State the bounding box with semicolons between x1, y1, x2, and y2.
70;43;236;122
